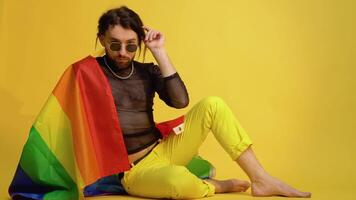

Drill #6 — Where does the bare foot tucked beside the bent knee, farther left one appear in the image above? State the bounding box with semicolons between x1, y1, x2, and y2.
206;179;250;193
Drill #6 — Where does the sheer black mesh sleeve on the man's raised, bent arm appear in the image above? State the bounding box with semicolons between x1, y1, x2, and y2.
150;64;189;108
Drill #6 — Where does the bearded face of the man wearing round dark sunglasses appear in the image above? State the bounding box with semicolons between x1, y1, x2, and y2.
99;25;138;68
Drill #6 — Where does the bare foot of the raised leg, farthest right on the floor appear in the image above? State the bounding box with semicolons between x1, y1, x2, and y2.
251;174;311;198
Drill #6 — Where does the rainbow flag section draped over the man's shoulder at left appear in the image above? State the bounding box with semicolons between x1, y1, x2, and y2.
9;56;130;199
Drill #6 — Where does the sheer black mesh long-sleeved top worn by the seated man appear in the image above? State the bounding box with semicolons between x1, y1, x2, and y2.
96;57;189;154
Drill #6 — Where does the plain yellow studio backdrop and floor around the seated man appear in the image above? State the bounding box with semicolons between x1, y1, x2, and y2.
0;0;356;199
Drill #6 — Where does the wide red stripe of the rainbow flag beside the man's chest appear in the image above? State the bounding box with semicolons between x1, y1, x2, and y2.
73;56;130;176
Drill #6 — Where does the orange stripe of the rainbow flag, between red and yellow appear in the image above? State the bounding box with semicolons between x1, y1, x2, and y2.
53;66;100;184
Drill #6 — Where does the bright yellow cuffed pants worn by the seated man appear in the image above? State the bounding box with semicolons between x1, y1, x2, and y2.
121;97;252;199
